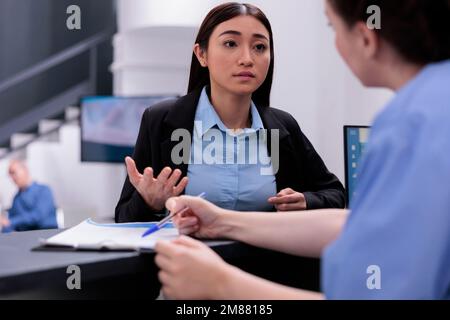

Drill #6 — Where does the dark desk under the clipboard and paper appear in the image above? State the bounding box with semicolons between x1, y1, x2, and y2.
0;230;320;299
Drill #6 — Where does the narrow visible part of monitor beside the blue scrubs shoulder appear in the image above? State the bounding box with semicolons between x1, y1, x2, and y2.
344;126;370;206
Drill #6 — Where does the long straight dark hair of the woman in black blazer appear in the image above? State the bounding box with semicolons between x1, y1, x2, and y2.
188;2;275;107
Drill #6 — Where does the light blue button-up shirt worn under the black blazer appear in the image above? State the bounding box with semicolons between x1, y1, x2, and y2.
186;88;277;211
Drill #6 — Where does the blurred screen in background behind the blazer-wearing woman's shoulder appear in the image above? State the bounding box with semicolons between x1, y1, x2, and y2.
81;95;177;163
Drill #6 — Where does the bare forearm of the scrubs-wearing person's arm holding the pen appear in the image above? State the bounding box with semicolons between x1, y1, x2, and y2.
219;209;347;257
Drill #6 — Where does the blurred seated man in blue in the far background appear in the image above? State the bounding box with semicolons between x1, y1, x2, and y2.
0;160;57;233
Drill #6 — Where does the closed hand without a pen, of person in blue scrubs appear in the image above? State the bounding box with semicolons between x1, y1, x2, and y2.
155;236;230;300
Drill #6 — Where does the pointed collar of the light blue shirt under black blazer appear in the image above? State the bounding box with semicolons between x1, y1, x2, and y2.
194;87;264;137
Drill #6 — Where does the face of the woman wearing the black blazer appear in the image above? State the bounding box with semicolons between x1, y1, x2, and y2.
196;16;270;95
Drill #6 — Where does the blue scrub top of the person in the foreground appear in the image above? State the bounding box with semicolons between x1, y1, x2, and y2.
322;60;450;299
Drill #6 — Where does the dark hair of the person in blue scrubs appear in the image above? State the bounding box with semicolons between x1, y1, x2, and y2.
328;0;450;64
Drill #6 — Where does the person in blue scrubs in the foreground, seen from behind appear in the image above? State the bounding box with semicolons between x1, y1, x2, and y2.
155;0;450;299
